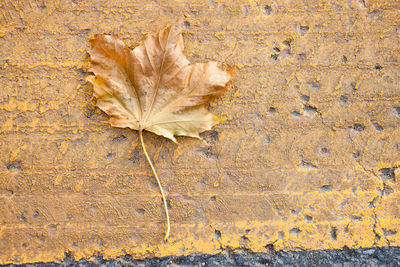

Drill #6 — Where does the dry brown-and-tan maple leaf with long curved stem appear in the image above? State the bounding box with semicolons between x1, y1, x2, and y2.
88;18;232;240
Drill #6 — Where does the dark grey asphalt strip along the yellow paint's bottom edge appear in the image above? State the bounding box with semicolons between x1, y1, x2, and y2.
5;247;400;267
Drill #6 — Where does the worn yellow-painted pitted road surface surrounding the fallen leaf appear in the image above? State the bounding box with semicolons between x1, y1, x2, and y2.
0;0;400;263
